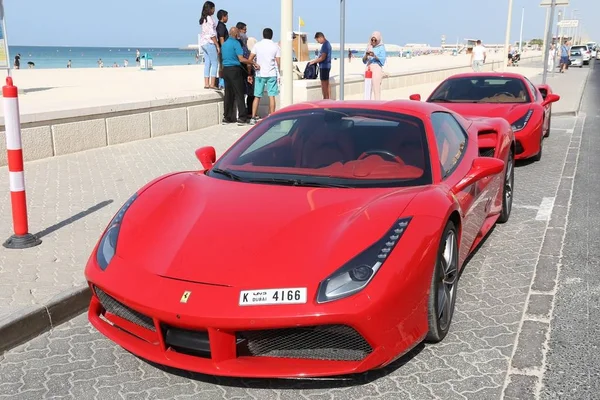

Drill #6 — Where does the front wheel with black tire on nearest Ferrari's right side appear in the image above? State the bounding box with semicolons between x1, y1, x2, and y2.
425;221;458;343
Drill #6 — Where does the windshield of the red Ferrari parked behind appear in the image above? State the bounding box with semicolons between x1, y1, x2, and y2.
428;76;530;103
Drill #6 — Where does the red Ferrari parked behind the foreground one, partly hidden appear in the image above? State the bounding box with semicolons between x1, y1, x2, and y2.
410;72;560;161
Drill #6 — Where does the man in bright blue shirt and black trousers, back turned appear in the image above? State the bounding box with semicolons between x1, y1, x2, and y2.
221;28;252;125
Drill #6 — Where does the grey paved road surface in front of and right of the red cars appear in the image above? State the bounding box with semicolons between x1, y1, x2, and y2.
0;72;600;400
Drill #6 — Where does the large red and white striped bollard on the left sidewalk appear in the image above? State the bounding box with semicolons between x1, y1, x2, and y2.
2;76;42;249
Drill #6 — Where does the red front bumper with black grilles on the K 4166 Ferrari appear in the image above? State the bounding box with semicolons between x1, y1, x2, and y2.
86;245;430;378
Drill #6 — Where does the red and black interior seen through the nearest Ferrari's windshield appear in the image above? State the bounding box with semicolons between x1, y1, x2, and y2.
228;115;430;179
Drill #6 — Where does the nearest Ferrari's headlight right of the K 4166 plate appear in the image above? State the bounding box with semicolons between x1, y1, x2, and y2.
317;217;411;303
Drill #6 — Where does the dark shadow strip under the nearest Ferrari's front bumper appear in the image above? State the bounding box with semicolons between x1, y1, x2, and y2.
141;342;425;390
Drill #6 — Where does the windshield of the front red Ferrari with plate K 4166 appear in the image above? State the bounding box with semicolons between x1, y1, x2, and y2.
208;108;432;188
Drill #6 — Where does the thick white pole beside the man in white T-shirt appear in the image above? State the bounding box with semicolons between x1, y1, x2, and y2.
280;0;294;108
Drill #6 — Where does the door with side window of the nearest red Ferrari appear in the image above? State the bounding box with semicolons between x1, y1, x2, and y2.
431;111;493;262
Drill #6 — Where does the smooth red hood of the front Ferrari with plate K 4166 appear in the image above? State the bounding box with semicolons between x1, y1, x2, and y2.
116;173;422;288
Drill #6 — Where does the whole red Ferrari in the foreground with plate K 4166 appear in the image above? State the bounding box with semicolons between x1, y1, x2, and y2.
85;101;516;377
